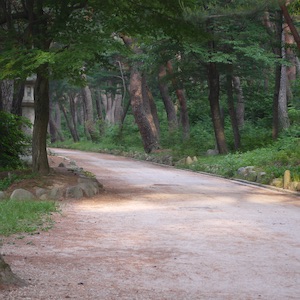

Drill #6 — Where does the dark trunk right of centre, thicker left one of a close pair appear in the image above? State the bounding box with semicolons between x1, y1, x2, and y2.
208;62;228;154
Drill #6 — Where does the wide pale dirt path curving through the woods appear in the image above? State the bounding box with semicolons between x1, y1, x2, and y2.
0;149;300;300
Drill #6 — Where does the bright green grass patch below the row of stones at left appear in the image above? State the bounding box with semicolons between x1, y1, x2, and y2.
0;200;57;236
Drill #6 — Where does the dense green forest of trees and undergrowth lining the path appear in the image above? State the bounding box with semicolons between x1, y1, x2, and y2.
0;0;300;188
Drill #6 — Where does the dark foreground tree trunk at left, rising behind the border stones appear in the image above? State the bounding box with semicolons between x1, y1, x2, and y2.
32;64;50;174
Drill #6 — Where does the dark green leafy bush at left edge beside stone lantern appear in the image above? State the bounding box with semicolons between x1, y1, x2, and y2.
0;111;31;169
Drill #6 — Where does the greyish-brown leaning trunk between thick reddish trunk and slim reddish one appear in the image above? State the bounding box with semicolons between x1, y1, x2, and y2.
158;66;178;132
